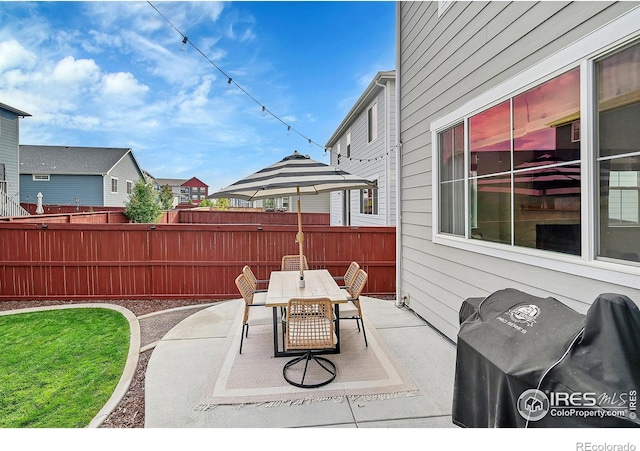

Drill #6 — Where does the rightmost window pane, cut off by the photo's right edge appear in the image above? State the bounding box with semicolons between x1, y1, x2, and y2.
596;45;640;261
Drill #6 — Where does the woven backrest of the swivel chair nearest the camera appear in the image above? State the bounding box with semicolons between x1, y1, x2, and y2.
286;298;335;349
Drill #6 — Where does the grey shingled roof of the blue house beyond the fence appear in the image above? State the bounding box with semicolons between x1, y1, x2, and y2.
20;145;142;175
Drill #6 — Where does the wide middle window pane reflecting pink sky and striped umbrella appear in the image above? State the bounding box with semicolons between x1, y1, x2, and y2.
469;68;581;255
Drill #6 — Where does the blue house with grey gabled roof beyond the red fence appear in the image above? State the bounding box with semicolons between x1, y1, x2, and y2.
20;145;144;207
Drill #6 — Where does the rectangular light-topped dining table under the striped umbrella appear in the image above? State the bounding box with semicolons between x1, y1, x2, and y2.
265;269;348;357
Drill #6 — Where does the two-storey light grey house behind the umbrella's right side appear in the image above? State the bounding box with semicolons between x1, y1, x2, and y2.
325;70;396;226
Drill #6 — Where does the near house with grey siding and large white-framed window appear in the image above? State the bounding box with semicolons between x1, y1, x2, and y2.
397;1;640;340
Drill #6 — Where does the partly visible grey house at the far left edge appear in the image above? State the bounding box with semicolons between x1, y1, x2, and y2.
0;103;31;216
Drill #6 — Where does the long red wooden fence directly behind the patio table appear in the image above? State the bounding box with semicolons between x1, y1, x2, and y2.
0;222;396;301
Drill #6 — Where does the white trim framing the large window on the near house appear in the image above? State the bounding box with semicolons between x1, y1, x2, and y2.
430;7;640;288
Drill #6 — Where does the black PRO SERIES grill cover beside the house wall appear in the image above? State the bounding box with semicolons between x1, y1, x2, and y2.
453;289;640;427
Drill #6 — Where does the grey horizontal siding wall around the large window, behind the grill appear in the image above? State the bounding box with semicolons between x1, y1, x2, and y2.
399;2;640;340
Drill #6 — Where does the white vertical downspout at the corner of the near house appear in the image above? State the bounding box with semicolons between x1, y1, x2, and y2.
396;2;405;308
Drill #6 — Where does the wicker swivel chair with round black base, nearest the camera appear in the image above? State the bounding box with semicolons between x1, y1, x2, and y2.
282;298;337;388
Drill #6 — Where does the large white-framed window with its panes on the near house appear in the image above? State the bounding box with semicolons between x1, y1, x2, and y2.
431;15;640;272
